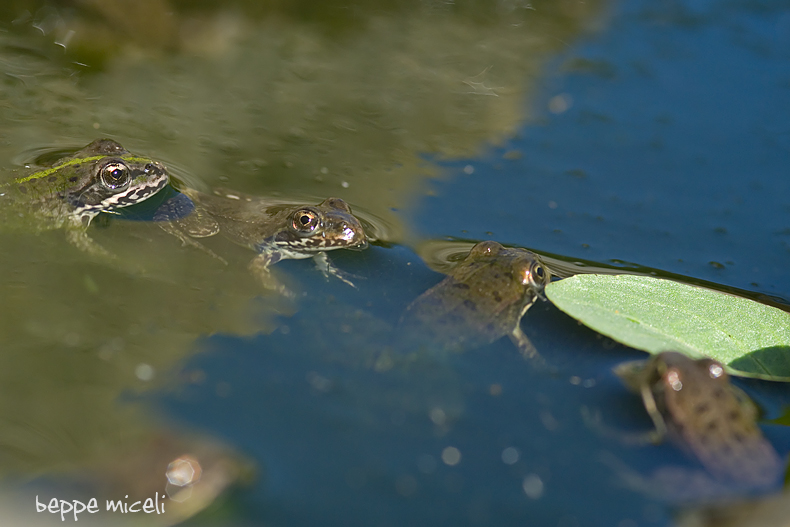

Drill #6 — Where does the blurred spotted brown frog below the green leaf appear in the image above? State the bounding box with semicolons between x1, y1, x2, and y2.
616;351;782;502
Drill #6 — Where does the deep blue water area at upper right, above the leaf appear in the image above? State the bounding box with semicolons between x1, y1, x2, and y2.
413;1;790;299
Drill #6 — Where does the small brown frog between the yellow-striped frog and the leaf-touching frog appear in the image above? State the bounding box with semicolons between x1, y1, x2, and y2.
162;188;368;295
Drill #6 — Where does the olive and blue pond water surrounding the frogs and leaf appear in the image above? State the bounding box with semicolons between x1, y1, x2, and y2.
0;0;790;527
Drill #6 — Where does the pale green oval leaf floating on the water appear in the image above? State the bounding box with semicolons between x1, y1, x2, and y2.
546;274;790;381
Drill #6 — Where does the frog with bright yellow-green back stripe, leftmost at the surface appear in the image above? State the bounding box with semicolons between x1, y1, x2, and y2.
0;139;170;258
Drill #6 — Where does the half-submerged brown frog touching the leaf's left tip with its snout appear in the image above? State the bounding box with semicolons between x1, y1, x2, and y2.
400;241;551;358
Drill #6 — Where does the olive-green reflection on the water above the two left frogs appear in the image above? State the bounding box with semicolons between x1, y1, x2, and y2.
0;2;608;239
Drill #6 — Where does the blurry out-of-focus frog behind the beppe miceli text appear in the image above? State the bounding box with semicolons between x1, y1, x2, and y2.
0;423;258;527
